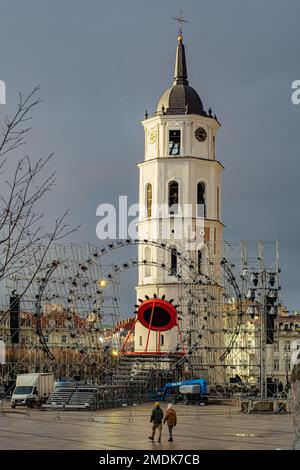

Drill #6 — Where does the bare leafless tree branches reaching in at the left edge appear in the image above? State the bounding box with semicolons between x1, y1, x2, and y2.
0;87;78;320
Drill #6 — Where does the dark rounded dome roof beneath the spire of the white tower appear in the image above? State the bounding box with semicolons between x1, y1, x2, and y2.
157;84;206;114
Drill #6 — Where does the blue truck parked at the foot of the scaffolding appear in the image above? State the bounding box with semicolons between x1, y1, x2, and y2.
157;379;208;405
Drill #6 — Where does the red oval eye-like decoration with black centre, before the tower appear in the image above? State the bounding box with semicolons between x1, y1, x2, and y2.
137;299;177;331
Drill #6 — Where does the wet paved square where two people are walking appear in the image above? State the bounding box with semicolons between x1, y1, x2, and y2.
0;404;293;450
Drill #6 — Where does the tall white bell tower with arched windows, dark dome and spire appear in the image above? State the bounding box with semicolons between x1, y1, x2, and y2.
135;31;223;354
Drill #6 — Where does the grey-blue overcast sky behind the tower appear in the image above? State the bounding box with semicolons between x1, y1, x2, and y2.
0;0;300;314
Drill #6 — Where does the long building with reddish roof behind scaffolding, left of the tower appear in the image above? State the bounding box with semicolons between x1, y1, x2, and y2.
0;304;103;383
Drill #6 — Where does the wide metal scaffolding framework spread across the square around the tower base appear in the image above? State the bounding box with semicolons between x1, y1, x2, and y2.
0;240;280;397
